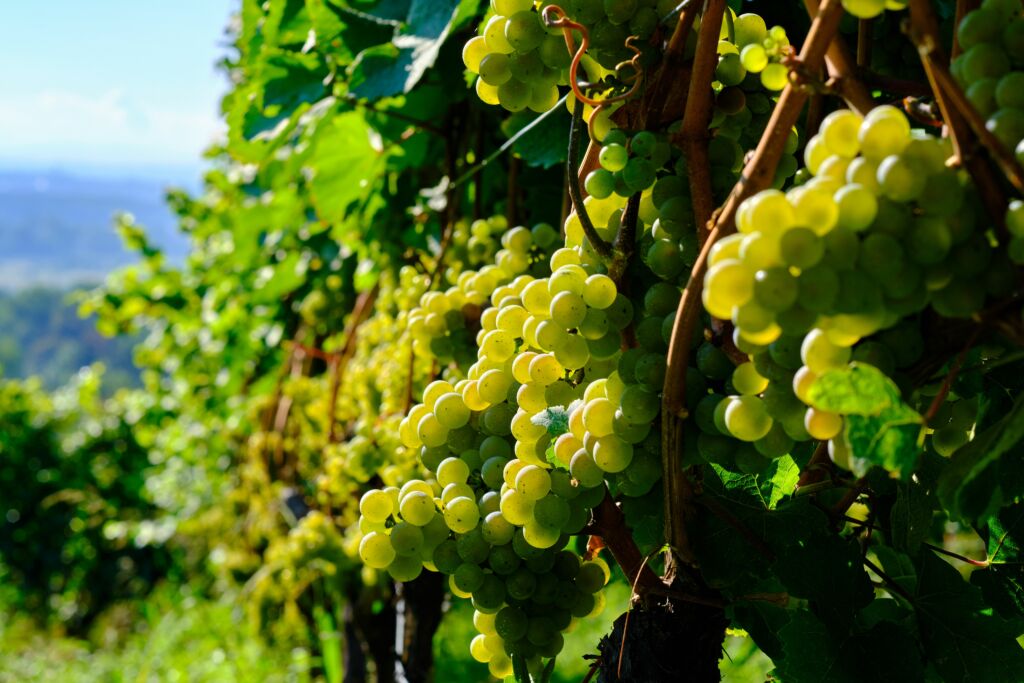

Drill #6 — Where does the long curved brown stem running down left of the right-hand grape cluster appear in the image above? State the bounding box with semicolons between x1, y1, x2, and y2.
662;0;843;573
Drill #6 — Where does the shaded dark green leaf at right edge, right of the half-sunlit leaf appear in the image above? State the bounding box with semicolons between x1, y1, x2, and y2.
938;389;1024;525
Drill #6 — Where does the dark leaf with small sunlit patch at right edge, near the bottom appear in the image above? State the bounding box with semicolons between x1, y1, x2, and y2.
971;503;1024;631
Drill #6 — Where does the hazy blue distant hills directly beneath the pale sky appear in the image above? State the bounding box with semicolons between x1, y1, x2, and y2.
0;170;187;289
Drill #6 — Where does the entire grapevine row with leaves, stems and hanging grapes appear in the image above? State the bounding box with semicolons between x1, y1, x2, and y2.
0;0;1024;683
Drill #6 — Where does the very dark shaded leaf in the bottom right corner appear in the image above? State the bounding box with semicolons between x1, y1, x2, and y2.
913;553;1024;683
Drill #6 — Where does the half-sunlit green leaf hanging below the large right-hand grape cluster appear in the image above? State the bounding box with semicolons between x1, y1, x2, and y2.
810;362;923;479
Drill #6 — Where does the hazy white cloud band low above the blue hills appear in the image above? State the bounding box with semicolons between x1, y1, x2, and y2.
0;88;223;164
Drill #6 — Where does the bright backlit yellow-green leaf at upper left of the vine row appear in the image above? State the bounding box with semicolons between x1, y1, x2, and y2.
308;112;384;223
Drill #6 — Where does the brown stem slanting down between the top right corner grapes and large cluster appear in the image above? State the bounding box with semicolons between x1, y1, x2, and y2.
910;0;1007;236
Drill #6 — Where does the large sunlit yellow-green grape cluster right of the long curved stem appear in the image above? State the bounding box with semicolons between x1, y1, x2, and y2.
697;106;1014;458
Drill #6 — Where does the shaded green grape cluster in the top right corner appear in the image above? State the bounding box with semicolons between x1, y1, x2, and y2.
950;0;1024;159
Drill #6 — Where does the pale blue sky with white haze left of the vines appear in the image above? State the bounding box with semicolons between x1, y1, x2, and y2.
0;0;238;176
